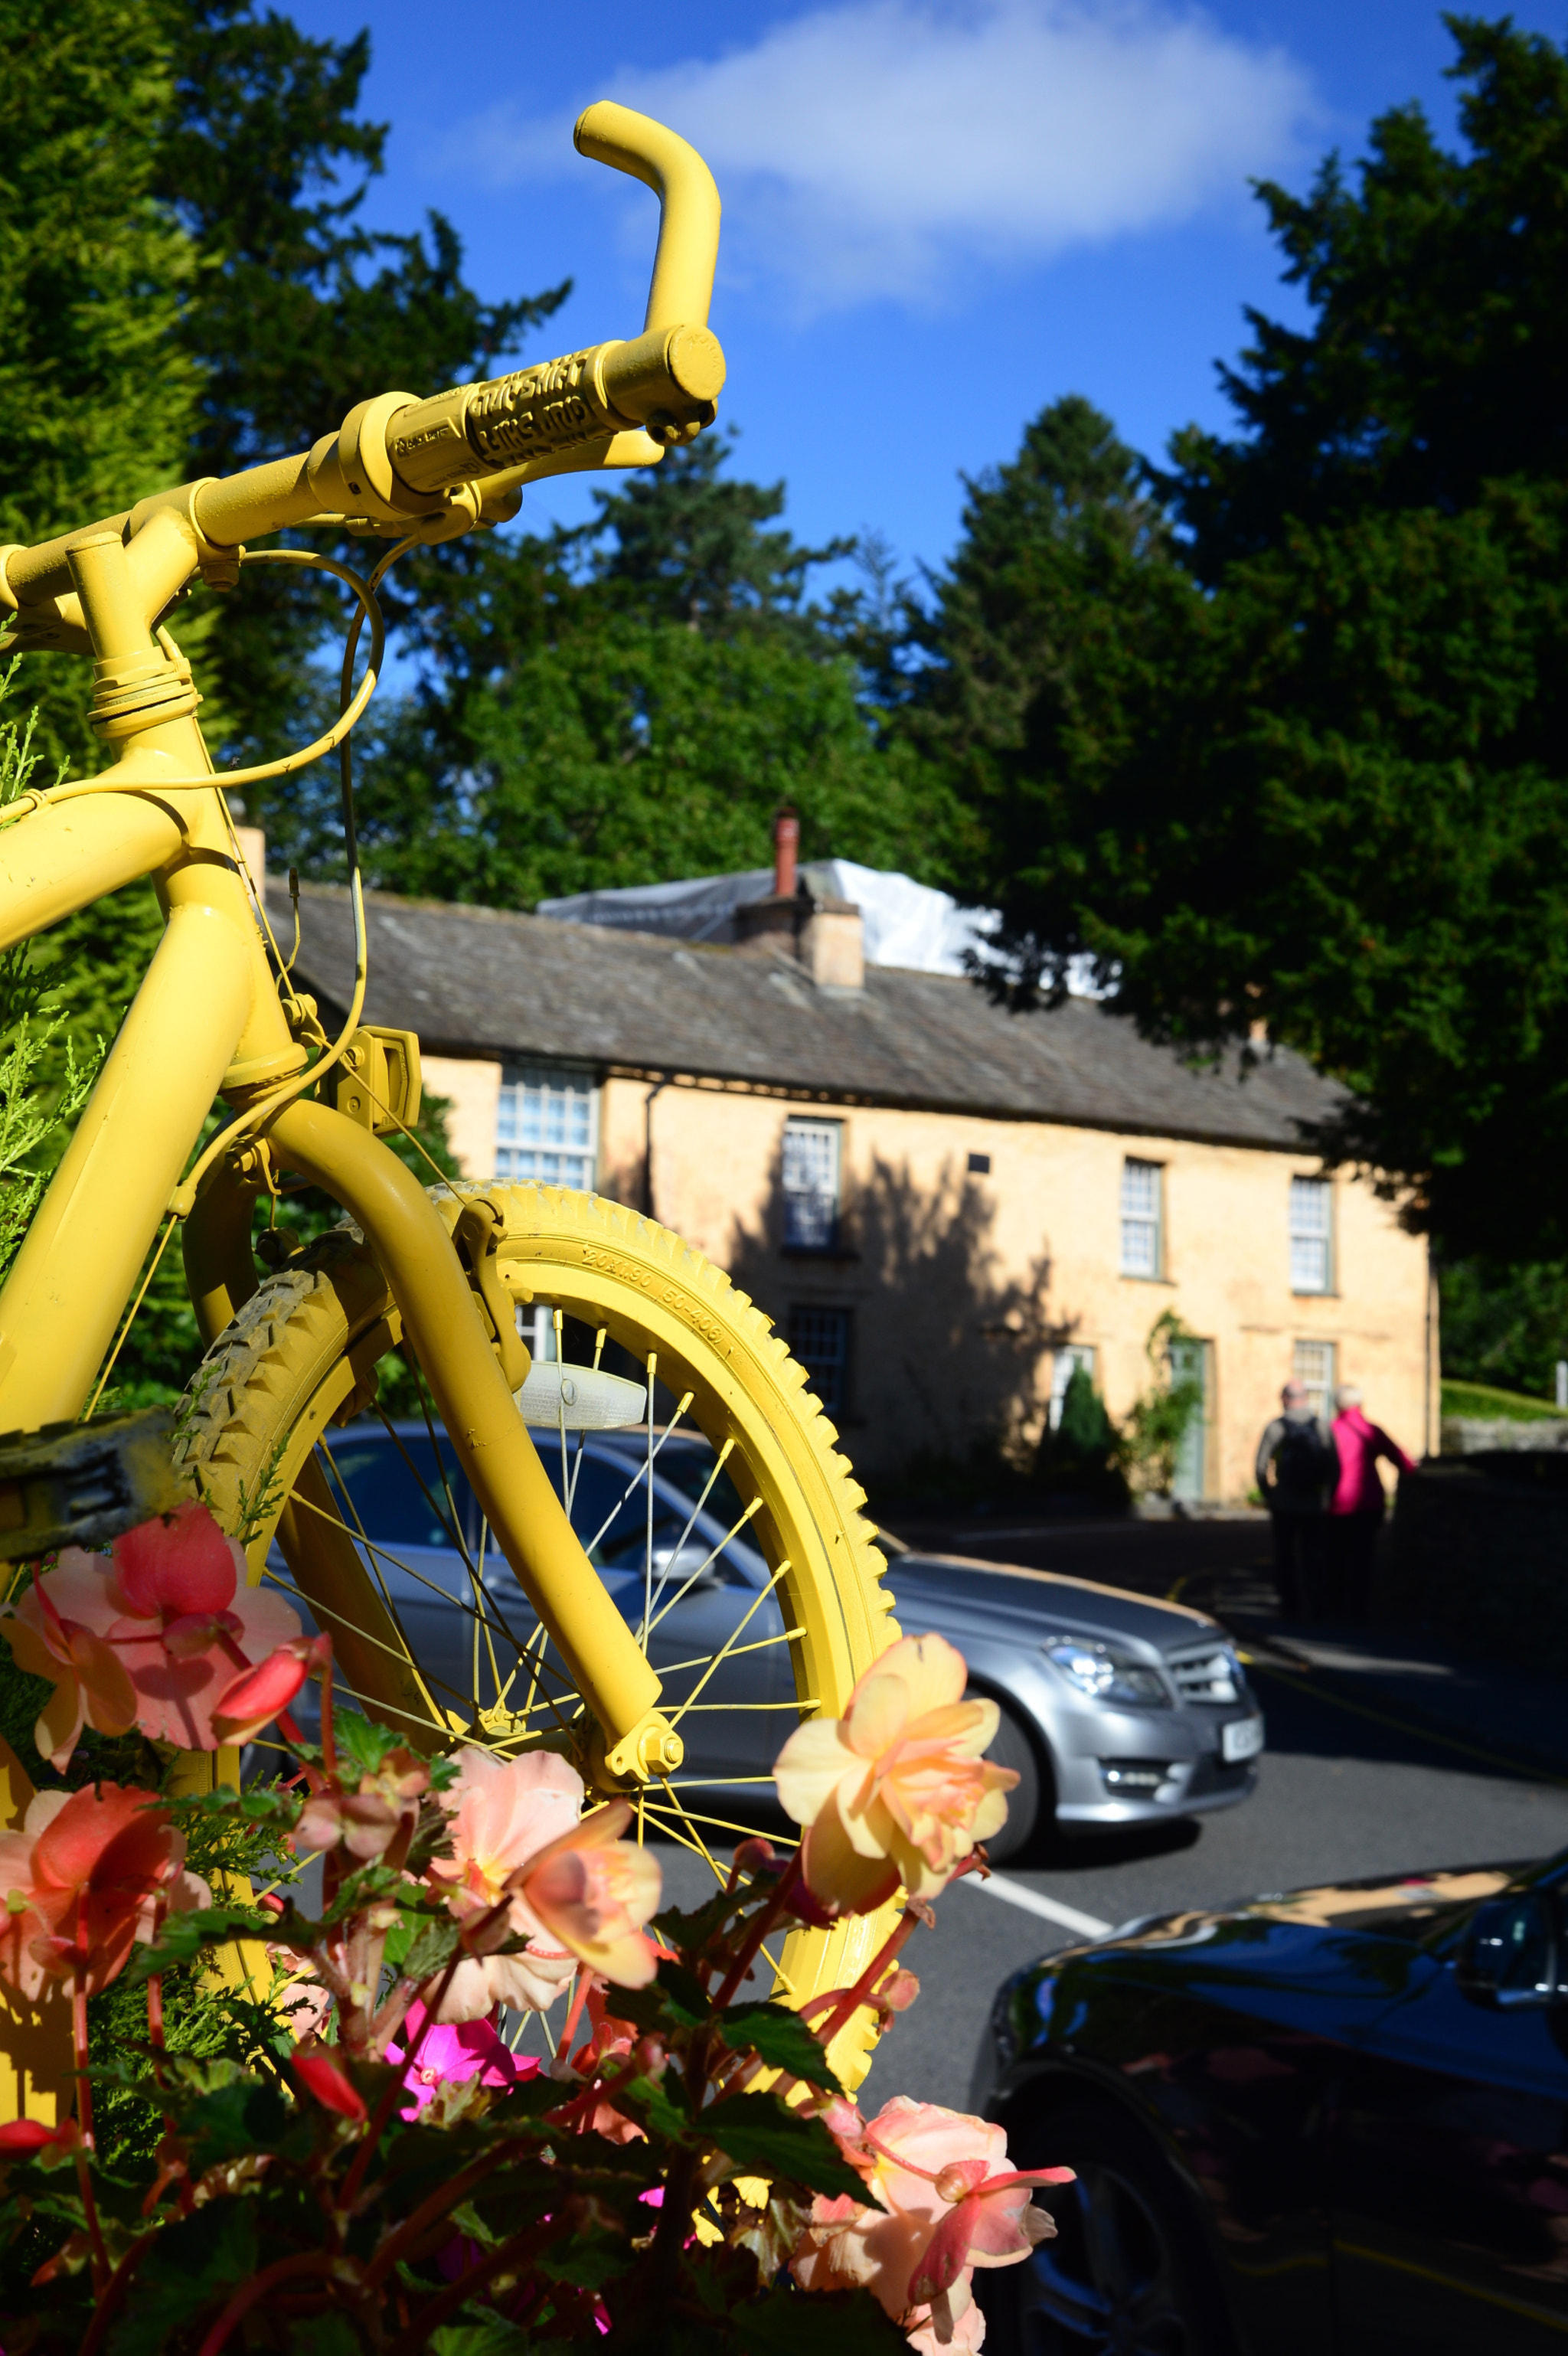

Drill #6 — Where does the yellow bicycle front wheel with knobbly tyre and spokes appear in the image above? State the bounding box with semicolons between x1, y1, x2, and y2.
179;1185;897;2083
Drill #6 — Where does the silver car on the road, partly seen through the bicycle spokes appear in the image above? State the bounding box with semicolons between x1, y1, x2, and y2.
276;1426;1264;1864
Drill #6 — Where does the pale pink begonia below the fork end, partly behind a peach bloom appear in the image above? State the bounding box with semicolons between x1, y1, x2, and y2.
429;1748;584;2024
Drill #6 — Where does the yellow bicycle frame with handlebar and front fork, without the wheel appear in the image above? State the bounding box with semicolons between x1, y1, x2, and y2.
0;92;723;1781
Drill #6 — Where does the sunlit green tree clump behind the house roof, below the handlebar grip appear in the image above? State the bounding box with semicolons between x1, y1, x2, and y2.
283;440;944;907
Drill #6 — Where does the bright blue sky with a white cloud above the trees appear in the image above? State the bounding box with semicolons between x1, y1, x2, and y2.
289;0;1568;589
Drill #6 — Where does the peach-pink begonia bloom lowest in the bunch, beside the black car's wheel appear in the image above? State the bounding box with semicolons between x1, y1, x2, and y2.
791;2094;1071;2356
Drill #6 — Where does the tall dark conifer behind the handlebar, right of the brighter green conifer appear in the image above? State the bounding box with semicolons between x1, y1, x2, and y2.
158;0;570;773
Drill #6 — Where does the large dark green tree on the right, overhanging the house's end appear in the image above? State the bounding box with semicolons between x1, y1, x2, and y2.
904;21;1568;1258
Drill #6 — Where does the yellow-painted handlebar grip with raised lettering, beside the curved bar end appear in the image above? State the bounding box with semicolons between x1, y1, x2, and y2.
386;323;725;495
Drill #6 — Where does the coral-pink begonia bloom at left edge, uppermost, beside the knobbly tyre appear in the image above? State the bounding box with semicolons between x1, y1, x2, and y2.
0;1503;299;1769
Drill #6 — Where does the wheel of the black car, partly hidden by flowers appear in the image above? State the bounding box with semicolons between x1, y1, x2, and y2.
975;2104;1233;2356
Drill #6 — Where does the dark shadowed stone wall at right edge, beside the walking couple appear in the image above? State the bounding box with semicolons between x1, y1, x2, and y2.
1375;1449;1568;1673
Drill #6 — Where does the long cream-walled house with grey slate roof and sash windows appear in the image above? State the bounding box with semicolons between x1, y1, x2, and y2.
266;881;1439;1501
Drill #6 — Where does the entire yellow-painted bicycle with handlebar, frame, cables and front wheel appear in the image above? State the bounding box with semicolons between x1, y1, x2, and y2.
0;103;897;2094
